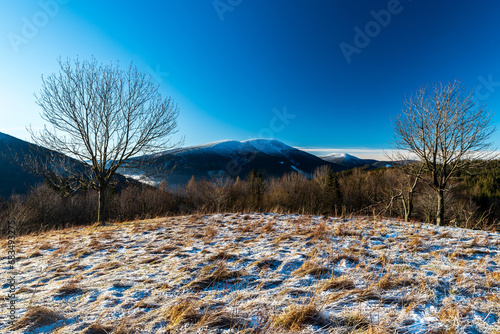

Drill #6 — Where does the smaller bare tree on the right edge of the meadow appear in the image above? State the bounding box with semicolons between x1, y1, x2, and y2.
394;81;495;225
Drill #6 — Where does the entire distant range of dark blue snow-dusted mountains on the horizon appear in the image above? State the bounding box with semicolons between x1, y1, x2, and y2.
0;133;387;198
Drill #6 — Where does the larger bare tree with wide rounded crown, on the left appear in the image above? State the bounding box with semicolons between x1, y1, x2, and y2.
30;59;178;221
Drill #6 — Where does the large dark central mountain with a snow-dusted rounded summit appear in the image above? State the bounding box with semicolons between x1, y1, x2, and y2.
134;139;346;186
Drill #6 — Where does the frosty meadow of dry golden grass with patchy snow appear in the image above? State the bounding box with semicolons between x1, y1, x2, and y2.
0;214;500;333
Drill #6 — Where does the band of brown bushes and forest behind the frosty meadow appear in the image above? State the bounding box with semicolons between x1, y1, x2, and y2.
0;160;500;235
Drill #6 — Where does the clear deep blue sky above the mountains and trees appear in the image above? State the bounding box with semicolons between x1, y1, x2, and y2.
0;0;500;159
